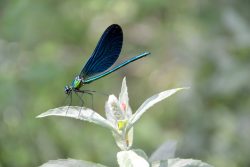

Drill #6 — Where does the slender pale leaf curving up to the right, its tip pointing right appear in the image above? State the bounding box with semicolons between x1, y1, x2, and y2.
127;88;187;129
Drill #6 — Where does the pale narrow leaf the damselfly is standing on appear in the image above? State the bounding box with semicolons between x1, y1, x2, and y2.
37;106;115;130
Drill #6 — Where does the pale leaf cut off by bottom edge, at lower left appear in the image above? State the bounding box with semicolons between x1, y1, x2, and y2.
40;159;107;167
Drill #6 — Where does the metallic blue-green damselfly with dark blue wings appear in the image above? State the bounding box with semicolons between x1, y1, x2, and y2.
64;24;150;100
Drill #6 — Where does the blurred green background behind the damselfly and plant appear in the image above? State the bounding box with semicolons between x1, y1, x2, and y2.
0;0;250;167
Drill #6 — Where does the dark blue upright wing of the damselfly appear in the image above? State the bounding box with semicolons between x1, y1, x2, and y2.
80;24;123;79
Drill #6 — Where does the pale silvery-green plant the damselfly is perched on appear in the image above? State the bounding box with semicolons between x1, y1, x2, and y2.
37;78;213;167
